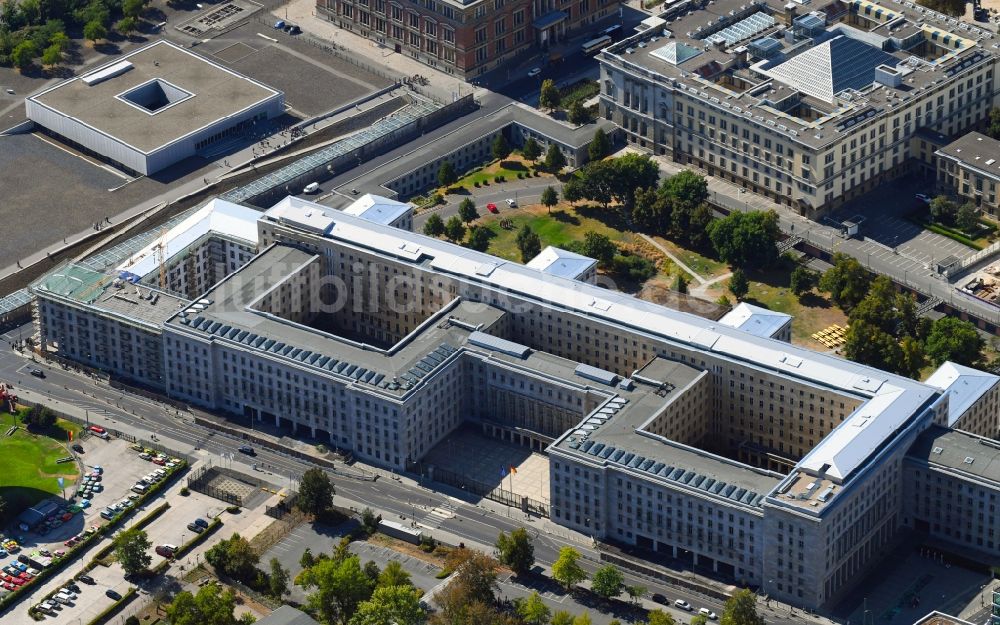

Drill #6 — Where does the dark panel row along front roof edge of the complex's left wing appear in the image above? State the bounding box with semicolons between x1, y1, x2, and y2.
180;314;458;391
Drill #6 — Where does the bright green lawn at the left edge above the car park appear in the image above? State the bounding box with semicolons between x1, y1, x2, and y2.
0;412;80;525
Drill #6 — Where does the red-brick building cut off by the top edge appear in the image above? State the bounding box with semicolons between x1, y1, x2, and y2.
316;0;619;79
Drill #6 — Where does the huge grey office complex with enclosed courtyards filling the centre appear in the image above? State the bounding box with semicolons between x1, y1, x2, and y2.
32;191;1000;608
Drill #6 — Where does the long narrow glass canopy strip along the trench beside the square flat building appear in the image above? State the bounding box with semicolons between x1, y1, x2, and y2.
222;101;441;202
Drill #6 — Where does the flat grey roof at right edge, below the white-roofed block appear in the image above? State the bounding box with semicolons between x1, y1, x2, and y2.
906;425;1000;487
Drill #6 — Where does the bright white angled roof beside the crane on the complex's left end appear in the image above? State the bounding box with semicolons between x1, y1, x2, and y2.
117;198;260;278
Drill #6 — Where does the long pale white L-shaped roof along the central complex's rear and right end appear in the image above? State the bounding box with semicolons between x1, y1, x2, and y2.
263;198;938;480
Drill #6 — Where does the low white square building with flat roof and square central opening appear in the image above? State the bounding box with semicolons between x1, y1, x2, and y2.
25;40;284;175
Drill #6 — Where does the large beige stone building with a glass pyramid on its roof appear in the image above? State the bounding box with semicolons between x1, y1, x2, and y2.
599;0;997;217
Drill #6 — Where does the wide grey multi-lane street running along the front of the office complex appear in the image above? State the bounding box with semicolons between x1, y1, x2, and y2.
0;326;802;623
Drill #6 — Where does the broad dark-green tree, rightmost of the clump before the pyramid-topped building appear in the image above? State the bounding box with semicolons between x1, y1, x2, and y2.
708;211;781;269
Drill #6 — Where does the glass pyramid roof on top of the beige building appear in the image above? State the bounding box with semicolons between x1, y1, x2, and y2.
764;35;899;102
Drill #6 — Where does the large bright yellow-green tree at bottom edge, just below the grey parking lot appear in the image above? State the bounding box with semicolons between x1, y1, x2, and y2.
300;555;372;625
